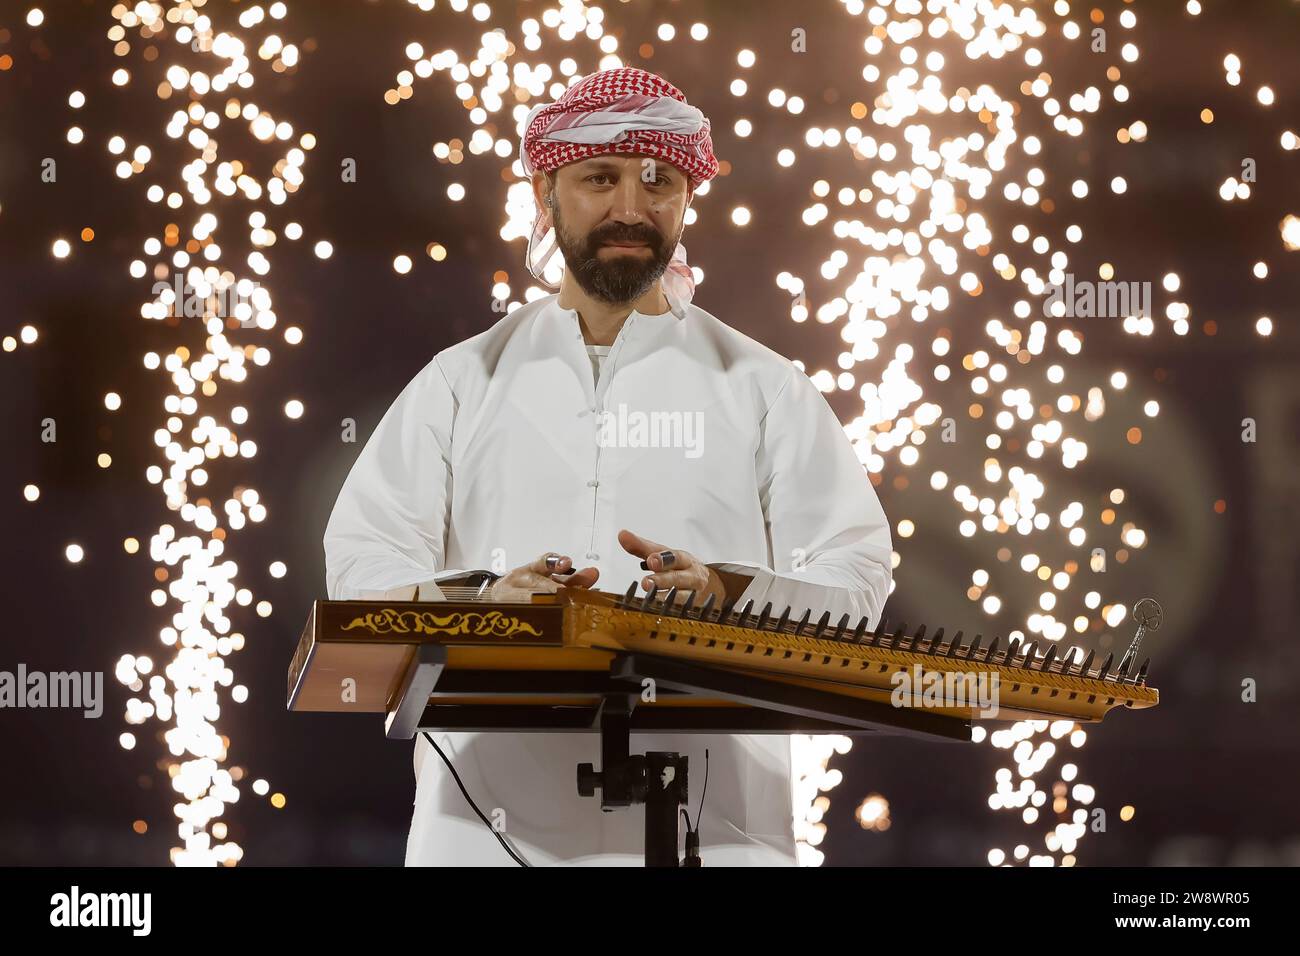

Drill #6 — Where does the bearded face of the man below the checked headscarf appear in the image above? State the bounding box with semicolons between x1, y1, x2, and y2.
538;153;689;304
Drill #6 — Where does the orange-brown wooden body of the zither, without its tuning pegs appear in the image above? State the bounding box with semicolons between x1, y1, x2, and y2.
289;589;1160;723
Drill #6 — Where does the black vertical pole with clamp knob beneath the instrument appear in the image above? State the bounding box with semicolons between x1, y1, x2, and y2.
577;693;699;866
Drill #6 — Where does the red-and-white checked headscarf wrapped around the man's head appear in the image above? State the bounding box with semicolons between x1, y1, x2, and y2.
519;66;718;303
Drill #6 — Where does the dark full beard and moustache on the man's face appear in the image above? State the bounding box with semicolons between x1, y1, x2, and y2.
553;207;680;304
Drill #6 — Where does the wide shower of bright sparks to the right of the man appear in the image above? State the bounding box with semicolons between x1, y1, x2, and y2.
790;0;1300;866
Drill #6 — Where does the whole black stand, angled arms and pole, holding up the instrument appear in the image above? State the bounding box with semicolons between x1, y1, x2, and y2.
385;644;971;866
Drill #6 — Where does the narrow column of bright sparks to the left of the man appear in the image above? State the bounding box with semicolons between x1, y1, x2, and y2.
108;0;315;866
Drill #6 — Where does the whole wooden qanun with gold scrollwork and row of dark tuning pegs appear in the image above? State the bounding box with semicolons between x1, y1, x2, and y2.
289;583;1160;739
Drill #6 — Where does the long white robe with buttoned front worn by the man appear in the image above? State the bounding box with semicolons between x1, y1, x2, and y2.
325;295;892;865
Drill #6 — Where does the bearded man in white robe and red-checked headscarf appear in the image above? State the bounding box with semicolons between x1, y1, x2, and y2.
325;69;892;865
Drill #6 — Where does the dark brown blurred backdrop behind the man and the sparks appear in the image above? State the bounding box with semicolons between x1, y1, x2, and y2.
0;0;1300;865
